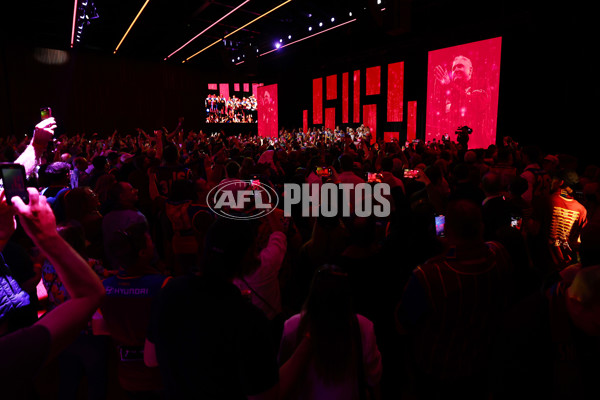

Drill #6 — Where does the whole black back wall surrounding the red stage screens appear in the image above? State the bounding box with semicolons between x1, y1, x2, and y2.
0;1;599;166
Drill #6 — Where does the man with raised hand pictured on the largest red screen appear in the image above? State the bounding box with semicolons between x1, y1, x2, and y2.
433;55;490;142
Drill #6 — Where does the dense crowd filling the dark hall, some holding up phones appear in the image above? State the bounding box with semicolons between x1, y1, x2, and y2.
0;114;600;399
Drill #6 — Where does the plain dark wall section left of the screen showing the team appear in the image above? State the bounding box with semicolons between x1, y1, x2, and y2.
0;45;254;139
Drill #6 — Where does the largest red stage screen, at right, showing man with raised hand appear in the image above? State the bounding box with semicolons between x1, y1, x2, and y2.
425;37;502;148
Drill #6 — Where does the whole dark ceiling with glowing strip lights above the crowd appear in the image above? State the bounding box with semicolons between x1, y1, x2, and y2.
0;0;591;77
